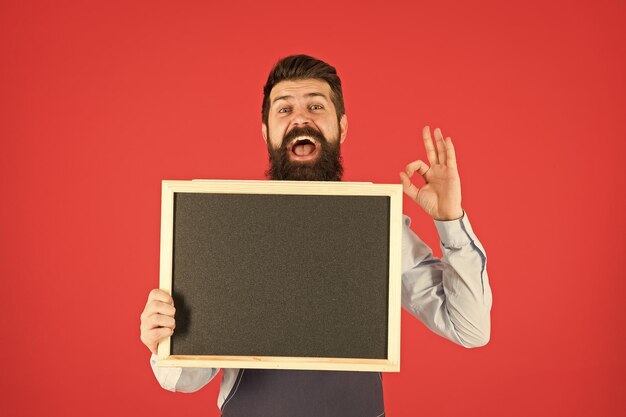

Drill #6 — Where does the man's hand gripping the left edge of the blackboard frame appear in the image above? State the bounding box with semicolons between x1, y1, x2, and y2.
140;288;176;353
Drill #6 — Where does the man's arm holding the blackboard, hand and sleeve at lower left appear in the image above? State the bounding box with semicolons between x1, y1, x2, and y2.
141;289;219;392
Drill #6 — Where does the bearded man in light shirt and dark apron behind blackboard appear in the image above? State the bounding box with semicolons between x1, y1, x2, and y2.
141;55;491;417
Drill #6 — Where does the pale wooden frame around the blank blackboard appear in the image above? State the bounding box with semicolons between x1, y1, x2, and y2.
157;180;402;372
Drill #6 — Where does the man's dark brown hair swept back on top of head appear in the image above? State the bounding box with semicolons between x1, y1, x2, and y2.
261;55;346;125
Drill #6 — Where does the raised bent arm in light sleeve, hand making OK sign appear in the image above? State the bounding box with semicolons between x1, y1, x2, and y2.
400;126;491;347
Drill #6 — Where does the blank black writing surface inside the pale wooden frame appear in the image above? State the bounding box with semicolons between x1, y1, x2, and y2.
171;193;389;358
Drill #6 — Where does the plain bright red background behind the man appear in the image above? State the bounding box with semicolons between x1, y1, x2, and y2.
0;1;626;417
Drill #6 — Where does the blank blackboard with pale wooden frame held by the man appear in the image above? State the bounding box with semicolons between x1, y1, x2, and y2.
159;181;401;370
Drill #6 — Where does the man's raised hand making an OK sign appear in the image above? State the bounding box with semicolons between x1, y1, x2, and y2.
400;126;463;220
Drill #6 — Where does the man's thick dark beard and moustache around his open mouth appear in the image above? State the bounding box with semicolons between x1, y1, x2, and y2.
265;126;343;181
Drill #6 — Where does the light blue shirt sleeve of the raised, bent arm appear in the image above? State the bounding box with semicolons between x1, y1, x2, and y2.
402;213;492;347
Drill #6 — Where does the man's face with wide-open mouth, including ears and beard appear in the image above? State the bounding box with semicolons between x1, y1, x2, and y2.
262;79;348;181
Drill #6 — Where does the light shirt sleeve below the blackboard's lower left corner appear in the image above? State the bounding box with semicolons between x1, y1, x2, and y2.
150;354;220;392
